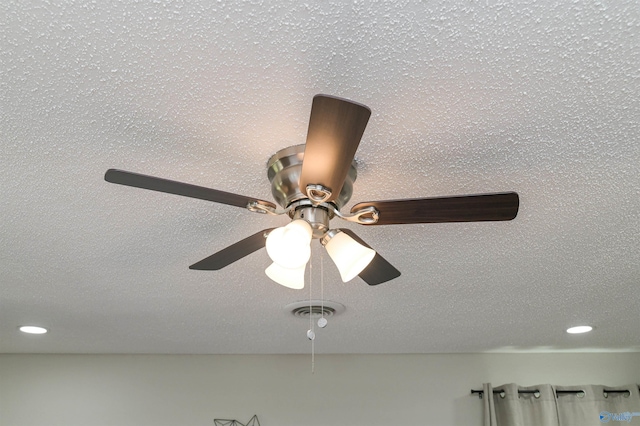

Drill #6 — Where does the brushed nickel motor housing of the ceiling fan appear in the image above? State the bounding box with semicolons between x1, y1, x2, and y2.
267;145;358;210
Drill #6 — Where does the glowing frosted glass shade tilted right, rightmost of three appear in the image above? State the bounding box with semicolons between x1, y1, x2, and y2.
325;232;376;283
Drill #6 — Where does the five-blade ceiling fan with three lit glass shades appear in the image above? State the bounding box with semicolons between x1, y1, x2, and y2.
104;95;519;288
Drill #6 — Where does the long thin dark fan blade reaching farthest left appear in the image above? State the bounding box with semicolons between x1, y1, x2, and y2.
104;169;276;208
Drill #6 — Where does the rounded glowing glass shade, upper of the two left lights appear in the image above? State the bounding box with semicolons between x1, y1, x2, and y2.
266;219;313;269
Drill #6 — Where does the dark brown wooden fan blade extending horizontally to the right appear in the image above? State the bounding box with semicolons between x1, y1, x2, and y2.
351;192;519;225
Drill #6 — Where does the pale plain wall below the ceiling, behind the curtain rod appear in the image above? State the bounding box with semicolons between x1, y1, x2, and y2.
0;353;640;426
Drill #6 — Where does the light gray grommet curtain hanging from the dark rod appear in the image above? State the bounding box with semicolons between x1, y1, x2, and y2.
483;383;640;426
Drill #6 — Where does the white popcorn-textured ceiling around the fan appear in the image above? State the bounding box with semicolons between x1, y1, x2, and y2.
0;0;640;354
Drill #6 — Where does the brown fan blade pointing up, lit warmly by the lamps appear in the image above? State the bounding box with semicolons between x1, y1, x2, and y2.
300;95;371;201
